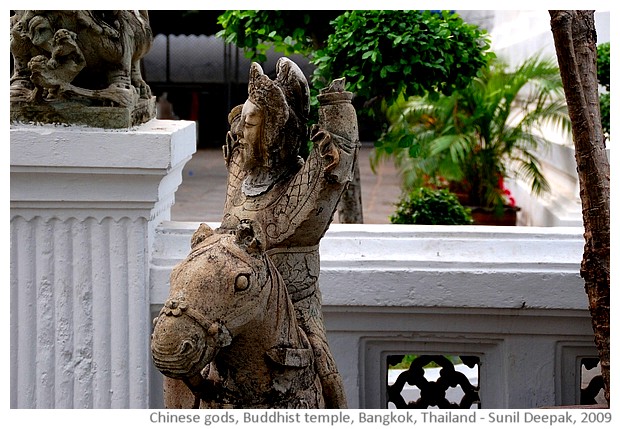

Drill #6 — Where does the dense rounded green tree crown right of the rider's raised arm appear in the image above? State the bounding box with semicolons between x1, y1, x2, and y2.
312;10;494;115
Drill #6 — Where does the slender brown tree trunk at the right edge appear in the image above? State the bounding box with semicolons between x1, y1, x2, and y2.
549;10;610;403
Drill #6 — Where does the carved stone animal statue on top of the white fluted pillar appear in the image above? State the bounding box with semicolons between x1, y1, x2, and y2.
10;10;155;128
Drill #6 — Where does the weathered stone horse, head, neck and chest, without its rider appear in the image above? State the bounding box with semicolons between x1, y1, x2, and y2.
151;221;325;408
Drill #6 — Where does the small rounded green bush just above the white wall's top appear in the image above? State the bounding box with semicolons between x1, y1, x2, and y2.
390;188;473;225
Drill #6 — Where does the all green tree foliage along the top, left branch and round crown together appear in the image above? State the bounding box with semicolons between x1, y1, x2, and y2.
217;10;493;120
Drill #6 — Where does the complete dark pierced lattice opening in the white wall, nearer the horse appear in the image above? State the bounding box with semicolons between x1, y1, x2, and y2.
387;355;480;409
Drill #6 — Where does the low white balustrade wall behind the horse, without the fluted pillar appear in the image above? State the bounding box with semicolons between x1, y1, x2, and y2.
150;222;596;408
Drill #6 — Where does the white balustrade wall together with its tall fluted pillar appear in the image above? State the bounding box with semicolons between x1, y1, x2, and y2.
10;120;596;408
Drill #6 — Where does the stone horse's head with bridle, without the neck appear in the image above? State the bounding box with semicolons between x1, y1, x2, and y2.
151;223;271;378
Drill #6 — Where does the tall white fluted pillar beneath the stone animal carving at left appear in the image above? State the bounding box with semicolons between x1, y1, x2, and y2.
10;120;196;408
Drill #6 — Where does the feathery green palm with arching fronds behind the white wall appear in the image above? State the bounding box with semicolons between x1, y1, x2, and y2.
373;57;570;224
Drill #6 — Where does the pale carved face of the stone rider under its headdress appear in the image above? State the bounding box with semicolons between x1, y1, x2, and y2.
241;100;268;168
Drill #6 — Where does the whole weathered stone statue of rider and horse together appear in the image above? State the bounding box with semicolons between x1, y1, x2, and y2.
152;58;359;408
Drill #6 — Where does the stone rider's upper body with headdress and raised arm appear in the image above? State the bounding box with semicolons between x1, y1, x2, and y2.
221;58;359;249
